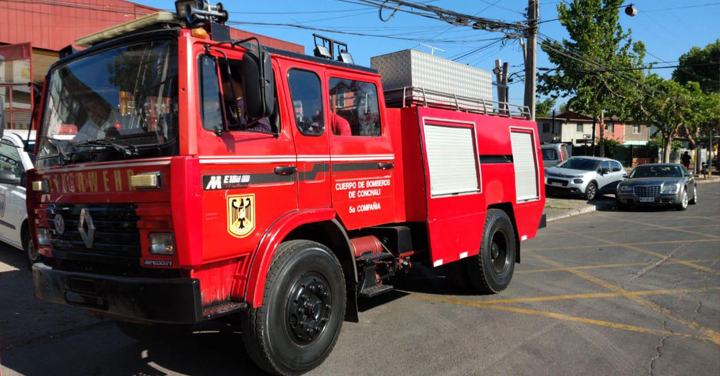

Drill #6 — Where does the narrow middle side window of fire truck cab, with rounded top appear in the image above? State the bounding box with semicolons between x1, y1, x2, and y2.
288;69;325;136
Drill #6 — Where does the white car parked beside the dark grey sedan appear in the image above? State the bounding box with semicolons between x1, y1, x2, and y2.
545;157;627;200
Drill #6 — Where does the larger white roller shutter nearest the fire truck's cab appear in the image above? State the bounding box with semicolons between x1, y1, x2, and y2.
425;124;480;196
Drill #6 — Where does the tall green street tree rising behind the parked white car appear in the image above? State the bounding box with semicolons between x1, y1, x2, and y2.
538;0;645;156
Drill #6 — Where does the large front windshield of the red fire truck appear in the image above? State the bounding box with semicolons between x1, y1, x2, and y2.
37;40;178;166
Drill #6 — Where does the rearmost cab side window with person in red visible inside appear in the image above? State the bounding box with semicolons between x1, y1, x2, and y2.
329;78;382;136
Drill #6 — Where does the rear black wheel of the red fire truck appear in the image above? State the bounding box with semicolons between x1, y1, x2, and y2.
465;209;517;294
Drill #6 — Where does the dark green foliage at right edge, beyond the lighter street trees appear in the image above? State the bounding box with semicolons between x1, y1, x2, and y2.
673;39;720;94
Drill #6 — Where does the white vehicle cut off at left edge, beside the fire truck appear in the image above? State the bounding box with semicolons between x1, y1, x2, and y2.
0;130;38;265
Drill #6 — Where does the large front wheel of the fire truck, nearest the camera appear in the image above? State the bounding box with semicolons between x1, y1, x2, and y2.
242;240;346;375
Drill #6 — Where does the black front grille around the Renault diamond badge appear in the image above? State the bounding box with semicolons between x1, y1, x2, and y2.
47;204;141;263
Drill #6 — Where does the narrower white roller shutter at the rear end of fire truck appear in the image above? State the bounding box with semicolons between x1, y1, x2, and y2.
510;132;538;202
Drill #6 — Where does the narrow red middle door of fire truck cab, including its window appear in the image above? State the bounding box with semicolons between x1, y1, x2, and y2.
286;65;330;209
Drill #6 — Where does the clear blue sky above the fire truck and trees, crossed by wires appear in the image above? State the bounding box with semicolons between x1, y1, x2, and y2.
146;0;720;103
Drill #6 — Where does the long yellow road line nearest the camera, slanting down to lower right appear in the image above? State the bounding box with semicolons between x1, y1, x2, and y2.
410;294;708;340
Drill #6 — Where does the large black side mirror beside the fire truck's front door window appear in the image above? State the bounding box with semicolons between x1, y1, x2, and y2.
241;47;275;119
